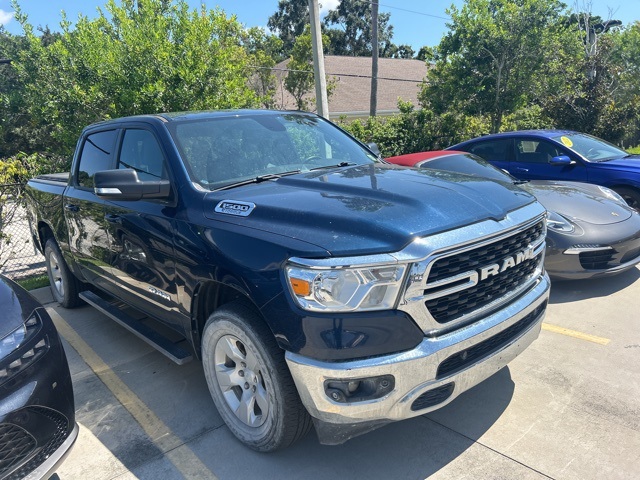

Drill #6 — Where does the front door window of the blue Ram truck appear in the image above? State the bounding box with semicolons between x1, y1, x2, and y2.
118;129;169;180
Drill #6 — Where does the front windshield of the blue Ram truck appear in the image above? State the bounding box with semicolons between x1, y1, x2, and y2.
169;113;376;190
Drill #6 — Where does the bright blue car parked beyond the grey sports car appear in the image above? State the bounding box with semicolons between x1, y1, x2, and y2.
447;130;640;210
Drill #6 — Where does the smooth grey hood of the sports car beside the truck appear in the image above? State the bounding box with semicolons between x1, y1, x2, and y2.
520;180;633;225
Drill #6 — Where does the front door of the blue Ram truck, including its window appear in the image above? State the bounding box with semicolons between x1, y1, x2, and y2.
104;127;177;330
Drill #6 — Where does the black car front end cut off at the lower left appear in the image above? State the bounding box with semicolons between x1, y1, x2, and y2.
0;275;78;480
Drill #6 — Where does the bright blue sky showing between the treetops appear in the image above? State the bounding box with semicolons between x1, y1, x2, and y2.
0;0;640;52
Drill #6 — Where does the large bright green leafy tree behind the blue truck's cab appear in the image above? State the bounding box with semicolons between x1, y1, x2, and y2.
8;0;259;159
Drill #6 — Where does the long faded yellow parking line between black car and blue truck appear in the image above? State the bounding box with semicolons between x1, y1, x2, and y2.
48;309;217;479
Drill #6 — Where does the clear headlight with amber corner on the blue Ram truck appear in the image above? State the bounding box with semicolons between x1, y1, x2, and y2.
285;262;406;312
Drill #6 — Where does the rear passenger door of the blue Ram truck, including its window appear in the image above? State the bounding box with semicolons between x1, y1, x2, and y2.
63;128;119;287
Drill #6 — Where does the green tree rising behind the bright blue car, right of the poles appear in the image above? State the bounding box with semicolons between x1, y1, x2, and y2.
421;0;564;132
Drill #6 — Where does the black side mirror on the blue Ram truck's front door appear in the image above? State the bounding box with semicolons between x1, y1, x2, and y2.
93;169;171;200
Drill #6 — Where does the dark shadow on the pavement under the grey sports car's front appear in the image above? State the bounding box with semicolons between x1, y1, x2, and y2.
549;268;640;303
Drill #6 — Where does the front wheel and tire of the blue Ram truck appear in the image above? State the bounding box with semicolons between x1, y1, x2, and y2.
202;303;312;452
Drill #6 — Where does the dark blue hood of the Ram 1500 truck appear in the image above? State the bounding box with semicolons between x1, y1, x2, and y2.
204;164;542;256
